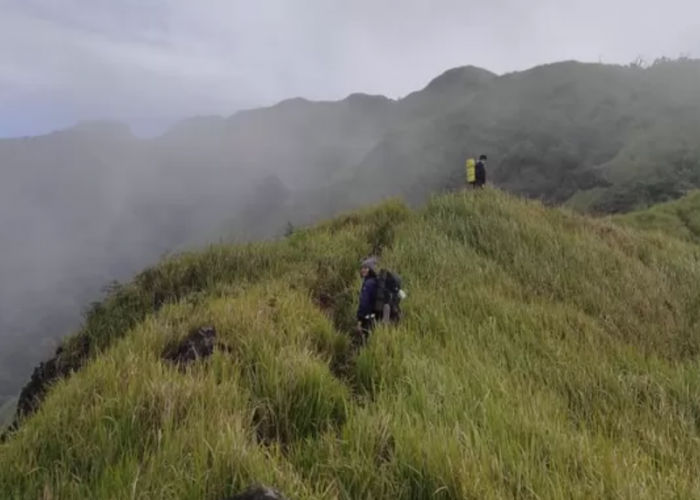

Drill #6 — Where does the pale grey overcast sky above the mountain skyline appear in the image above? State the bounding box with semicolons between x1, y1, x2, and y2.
0;0;700;136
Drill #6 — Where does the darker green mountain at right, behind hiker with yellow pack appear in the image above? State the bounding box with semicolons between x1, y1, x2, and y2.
219;59;700;243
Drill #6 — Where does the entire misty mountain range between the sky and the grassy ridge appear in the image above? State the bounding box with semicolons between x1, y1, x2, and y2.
5;58;700;412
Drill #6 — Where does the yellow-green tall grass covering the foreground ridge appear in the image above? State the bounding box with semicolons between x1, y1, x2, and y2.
0;189;700;500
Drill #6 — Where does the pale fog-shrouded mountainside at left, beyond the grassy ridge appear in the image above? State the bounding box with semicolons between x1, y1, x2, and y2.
0;88;422;406
